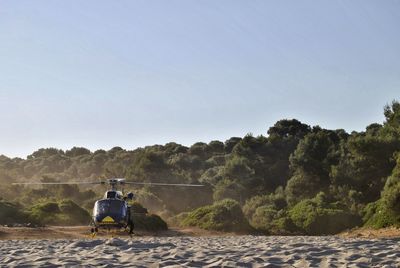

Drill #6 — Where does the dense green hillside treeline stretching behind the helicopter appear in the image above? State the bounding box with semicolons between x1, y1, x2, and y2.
0;101;400;234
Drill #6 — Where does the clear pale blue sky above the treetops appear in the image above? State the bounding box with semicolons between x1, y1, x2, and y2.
0;0;400;157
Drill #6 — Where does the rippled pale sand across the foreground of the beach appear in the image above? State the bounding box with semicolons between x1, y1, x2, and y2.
0;235;400;267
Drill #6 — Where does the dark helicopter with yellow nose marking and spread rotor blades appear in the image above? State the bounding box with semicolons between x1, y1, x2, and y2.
12;178;204;235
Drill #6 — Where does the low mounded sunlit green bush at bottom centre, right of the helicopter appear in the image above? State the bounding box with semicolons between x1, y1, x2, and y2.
182;199;252;232
